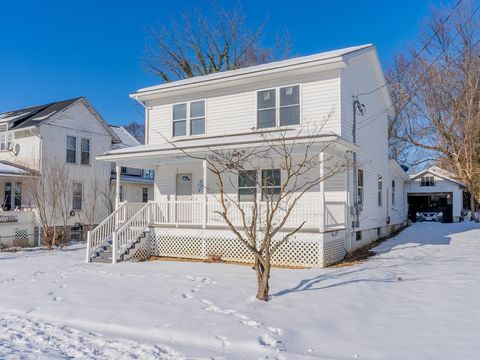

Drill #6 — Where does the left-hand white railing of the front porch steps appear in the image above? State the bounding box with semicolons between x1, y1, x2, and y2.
86;202;127;263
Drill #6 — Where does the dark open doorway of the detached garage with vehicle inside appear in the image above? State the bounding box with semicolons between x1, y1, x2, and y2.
408;193;453;223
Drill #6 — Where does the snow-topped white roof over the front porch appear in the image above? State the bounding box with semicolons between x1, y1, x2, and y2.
97;129;358;165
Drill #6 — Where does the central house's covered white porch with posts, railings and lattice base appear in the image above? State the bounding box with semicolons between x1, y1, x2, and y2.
87;132;356;266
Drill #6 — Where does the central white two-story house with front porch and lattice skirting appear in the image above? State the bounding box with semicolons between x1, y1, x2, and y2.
87;45;408;266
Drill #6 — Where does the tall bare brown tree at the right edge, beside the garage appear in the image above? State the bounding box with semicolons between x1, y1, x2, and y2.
390;1;480;219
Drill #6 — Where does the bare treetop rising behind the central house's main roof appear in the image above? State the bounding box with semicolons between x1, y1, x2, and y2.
144;4;290;82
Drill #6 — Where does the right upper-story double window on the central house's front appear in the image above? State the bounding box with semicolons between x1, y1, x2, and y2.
257;85;300;129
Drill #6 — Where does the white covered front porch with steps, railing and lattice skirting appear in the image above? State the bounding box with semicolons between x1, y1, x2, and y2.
87;134;356;266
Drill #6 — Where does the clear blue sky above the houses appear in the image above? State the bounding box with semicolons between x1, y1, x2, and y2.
0;0;442;124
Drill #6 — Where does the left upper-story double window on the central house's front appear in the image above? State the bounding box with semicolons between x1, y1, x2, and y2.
172;100;205;137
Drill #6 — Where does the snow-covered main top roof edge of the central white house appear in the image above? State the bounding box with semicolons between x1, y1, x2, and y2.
130;44;373;98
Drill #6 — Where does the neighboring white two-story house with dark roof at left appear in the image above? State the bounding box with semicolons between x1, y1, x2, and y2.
0;97;153;246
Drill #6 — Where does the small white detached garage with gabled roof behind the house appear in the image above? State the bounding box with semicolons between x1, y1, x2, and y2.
407;166;465;222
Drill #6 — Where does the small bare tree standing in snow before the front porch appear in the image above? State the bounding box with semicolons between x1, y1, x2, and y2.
158;114;349;301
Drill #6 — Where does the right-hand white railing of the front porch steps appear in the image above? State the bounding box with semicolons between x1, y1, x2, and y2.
112;202;152;264
